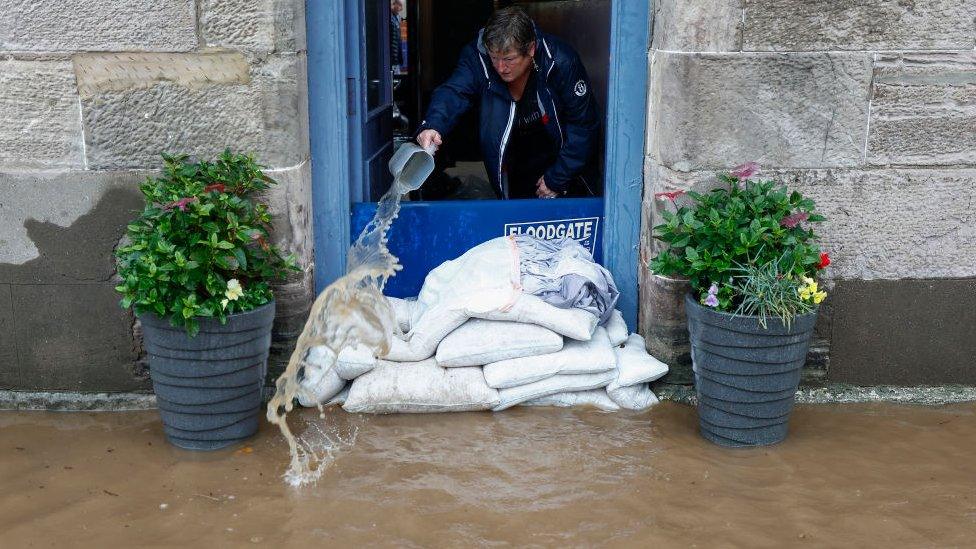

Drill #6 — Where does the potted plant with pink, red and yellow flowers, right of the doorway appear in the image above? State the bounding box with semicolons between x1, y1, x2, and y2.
650;163;830;446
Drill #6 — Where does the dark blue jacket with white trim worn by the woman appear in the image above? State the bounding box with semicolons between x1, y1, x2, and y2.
417;30;600;194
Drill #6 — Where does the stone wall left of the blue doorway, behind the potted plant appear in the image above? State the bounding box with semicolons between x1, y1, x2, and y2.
0;0;313;391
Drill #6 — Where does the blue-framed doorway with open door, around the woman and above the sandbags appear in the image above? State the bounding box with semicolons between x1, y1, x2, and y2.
306;0;652;325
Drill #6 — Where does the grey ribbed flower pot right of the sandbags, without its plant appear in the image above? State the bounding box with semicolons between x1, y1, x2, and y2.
685;295;817;447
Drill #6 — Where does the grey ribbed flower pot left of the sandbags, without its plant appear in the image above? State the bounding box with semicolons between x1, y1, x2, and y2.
139;301;275;450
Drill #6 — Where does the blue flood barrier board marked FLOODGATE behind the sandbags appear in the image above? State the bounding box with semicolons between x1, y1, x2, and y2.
351;198;603;297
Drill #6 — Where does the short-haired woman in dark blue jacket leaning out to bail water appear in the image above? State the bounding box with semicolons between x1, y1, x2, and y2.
417;7;599;198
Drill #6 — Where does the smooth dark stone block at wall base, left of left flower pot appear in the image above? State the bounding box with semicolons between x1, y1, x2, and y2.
0;283;148;391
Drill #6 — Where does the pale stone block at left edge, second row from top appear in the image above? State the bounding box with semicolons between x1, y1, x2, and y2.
0;58;84;168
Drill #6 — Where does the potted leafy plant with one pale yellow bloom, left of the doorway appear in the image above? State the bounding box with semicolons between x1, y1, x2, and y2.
116;151;296;450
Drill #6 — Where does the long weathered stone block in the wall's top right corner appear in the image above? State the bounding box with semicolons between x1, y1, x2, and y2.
743;0;976;51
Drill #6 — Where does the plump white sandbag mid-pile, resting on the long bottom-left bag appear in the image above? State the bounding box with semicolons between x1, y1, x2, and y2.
436;318;563;368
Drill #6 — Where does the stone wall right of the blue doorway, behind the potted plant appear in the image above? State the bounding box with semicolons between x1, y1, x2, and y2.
641;0;976;384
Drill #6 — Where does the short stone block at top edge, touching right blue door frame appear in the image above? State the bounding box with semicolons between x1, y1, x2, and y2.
653;0;742;51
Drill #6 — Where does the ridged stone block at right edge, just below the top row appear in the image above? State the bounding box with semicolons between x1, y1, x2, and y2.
867;52;976;165
